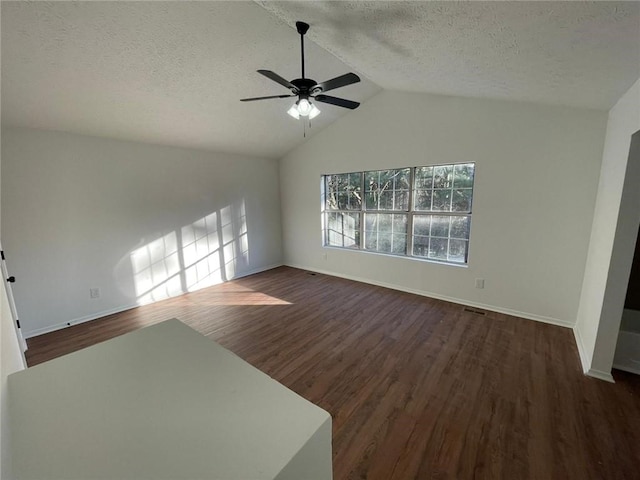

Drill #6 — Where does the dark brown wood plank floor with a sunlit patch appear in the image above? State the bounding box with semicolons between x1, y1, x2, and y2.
28;267;640;480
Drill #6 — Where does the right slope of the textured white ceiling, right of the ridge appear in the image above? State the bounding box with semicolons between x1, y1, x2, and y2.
260;1;640;109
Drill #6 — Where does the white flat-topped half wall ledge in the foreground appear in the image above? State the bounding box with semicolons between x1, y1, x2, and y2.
9;319;332;480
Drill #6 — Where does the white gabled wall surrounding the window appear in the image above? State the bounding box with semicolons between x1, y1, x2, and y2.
280;91;607;326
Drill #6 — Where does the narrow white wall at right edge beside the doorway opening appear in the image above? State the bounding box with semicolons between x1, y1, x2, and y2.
575;80;640;380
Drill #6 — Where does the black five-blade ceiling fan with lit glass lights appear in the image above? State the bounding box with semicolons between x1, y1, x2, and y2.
240;22;360;119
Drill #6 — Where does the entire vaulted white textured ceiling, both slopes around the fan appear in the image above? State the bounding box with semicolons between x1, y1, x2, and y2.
1;1;640;158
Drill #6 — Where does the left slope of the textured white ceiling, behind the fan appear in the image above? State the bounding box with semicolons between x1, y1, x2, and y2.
1;1;379;158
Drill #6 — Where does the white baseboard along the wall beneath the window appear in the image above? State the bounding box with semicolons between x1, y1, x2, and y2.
285;263;574;328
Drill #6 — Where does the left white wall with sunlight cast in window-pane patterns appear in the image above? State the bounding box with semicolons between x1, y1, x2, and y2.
2;129;282;337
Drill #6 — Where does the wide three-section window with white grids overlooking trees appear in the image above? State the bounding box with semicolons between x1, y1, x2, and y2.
322;163;475;264
